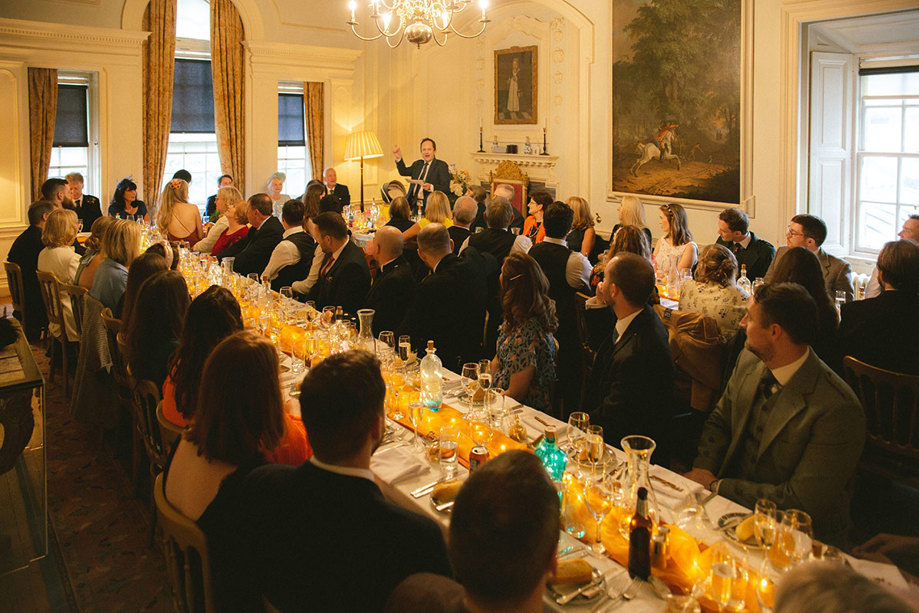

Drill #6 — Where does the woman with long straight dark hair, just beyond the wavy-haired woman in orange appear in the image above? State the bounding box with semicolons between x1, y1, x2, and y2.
123;268;191;388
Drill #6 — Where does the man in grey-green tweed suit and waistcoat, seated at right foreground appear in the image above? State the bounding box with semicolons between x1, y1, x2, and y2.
686;283;865;546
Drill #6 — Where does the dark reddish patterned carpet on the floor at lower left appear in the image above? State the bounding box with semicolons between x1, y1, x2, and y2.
30;347;173;612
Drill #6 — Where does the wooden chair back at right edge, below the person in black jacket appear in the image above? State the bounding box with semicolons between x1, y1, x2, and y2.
842;356;919;488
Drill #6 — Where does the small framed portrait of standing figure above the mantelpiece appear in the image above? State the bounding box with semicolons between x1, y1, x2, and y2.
495;46;538;125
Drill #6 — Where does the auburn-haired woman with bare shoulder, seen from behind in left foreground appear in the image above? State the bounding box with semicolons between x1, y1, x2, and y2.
164;330;306;611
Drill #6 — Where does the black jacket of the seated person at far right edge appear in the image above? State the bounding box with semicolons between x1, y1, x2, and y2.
839;290;919;375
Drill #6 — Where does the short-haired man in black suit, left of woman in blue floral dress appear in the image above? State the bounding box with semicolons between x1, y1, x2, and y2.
399;223;486;370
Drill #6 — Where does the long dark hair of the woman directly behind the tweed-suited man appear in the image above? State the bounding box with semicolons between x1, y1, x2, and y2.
772;247;842;373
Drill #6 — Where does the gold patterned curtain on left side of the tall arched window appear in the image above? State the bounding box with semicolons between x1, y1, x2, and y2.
143;0;176;219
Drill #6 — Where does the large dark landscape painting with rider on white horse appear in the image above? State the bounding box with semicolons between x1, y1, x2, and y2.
612;0;742;204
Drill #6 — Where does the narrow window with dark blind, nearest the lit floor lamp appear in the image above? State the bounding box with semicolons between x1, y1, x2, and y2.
278;83;313;196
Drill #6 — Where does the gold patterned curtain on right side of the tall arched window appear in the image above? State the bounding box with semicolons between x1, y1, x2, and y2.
211;0;246;194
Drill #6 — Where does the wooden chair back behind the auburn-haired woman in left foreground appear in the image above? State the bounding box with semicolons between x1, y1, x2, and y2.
153;473;215;613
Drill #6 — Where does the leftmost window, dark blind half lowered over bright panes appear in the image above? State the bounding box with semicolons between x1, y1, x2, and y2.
48;74;95;192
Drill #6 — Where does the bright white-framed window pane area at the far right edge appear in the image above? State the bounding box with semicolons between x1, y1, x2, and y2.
855;66;919;252
